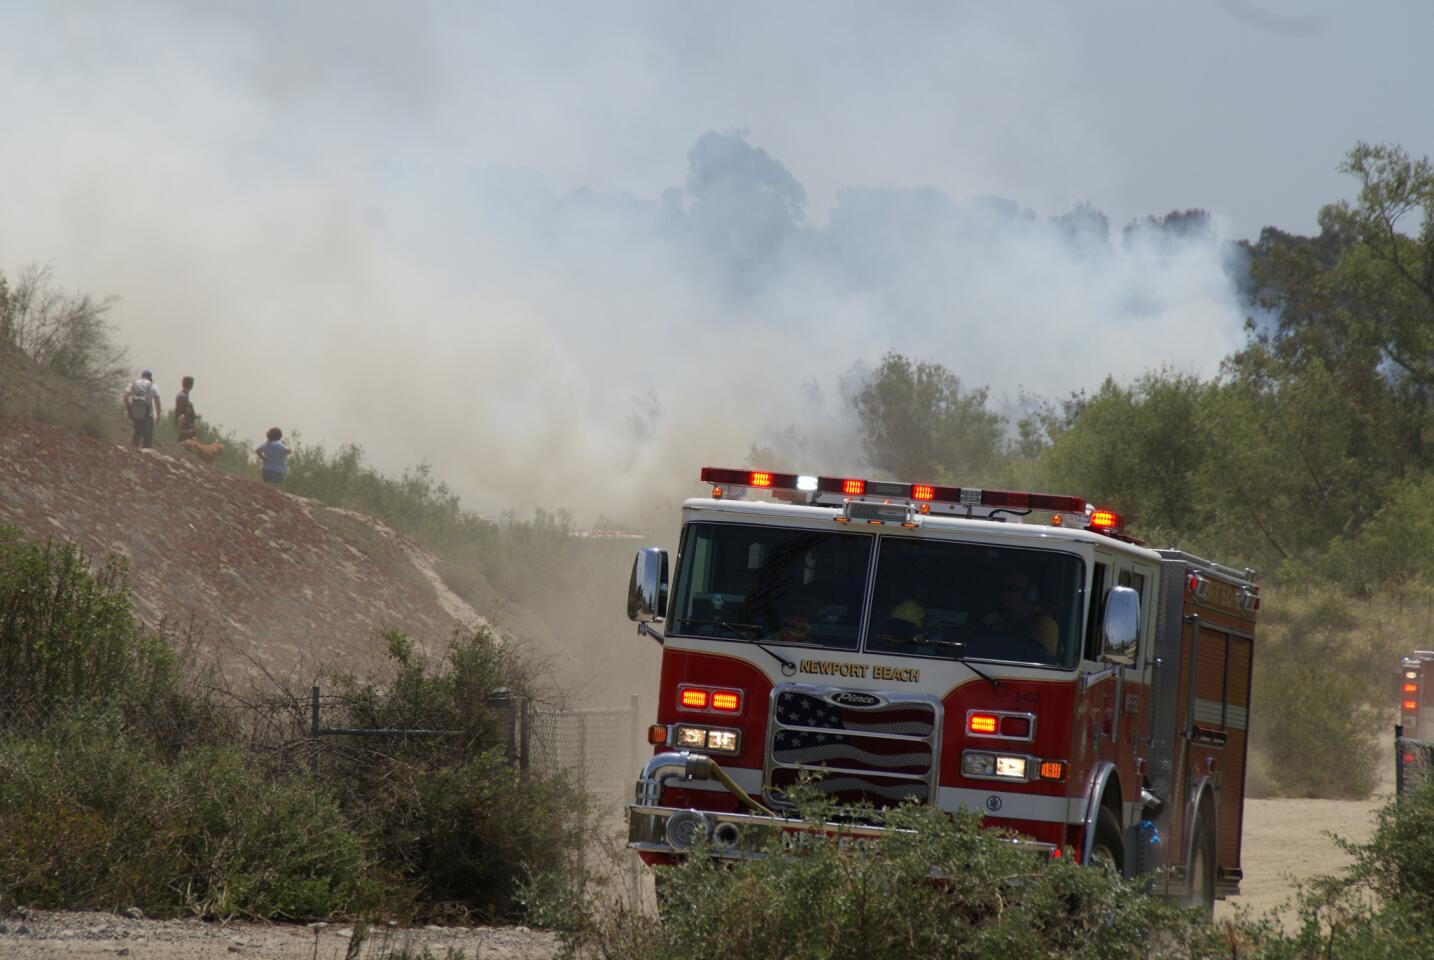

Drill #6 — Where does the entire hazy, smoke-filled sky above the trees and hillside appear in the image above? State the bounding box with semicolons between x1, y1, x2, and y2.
0;0;1434;517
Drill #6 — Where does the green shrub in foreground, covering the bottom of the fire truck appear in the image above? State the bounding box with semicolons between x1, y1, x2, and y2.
529;806;1215;960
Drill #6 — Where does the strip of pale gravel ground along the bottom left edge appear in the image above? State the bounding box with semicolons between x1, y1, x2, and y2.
0;910;556;960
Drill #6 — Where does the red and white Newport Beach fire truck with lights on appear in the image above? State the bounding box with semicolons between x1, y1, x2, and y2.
628;468;1259;907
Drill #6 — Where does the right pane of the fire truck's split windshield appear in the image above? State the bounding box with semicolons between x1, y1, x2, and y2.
866;537;1086;666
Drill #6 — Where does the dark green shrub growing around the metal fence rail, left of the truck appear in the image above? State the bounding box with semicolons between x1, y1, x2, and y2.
323;630;585;918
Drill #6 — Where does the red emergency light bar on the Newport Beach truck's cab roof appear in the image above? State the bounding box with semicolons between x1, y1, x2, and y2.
701;466;1126;540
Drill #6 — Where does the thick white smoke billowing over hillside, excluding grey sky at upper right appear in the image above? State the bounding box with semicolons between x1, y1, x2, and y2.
0;3;1243;519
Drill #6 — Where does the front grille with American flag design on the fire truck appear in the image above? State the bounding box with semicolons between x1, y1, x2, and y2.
764;684;941;808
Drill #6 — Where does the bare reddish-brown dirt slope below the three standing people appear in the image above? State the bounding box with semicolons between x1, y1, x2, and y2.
0;416;482;683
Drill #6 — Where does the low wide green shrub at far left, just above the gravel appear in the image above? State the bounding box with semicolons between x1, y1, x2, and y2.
0;712;374;917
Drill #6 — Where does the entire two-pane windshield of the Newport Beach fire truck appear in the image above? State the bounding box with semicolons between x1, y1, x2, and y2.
668;522;1086;666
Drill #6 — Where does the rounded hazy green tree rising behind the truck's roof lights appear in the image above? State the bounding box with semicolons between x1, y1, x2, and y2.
852;353;1005;484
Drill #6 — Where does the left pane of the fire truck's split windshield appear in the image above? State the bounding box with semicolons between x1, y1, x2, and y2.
668;524;876;650
